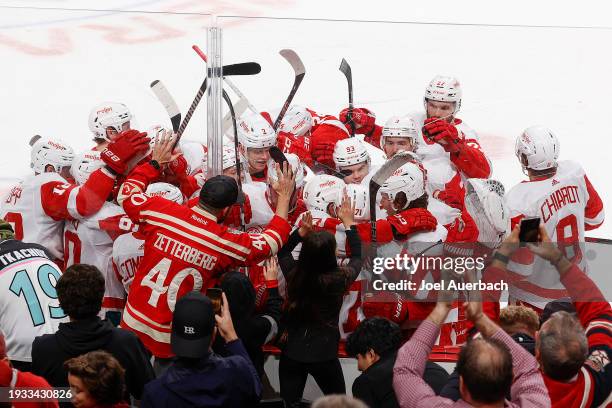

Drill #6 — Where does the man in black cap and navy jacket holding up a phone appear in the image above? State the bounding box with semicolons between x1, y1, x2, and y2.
141;292;261;407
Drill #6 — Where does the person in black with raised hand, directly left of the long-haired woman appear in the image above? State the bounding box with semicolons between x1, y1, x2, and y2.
214;258;283;378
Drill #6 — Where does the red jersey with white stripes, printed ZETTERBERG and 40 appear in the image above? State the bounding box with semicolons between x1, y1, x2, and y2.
119;175;290;358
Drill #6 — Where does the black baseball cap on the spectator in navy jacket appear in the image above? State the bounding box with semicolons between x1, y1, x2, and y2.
170;292;215;358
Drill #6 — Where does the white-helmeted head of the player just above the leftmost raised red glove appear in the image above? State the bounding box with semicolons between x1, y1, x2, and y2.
89;102;132;152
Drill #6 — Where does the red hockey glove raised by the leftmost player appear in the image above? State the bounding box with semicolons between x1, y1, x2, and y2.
100;129;150;174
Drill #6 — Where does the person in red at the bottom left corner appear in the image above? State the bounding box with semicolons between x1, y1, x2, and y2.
0;333;58;408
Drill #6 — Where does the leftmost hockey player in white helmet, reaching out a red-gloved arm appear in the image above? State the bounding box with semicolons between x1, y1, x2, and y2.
0;130;149;263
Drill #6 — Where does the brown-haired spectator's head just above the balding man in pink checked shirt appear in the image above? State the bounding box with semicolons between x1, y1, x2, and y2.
499;306;540;355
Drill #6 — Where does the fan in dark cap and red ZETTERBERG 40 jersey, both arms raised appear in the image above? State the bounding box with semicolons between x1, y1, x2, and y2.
118;137;295;359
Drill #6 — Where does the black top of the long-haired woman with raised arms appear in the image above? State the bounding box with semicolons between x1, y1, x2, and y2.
278;227;362;363
